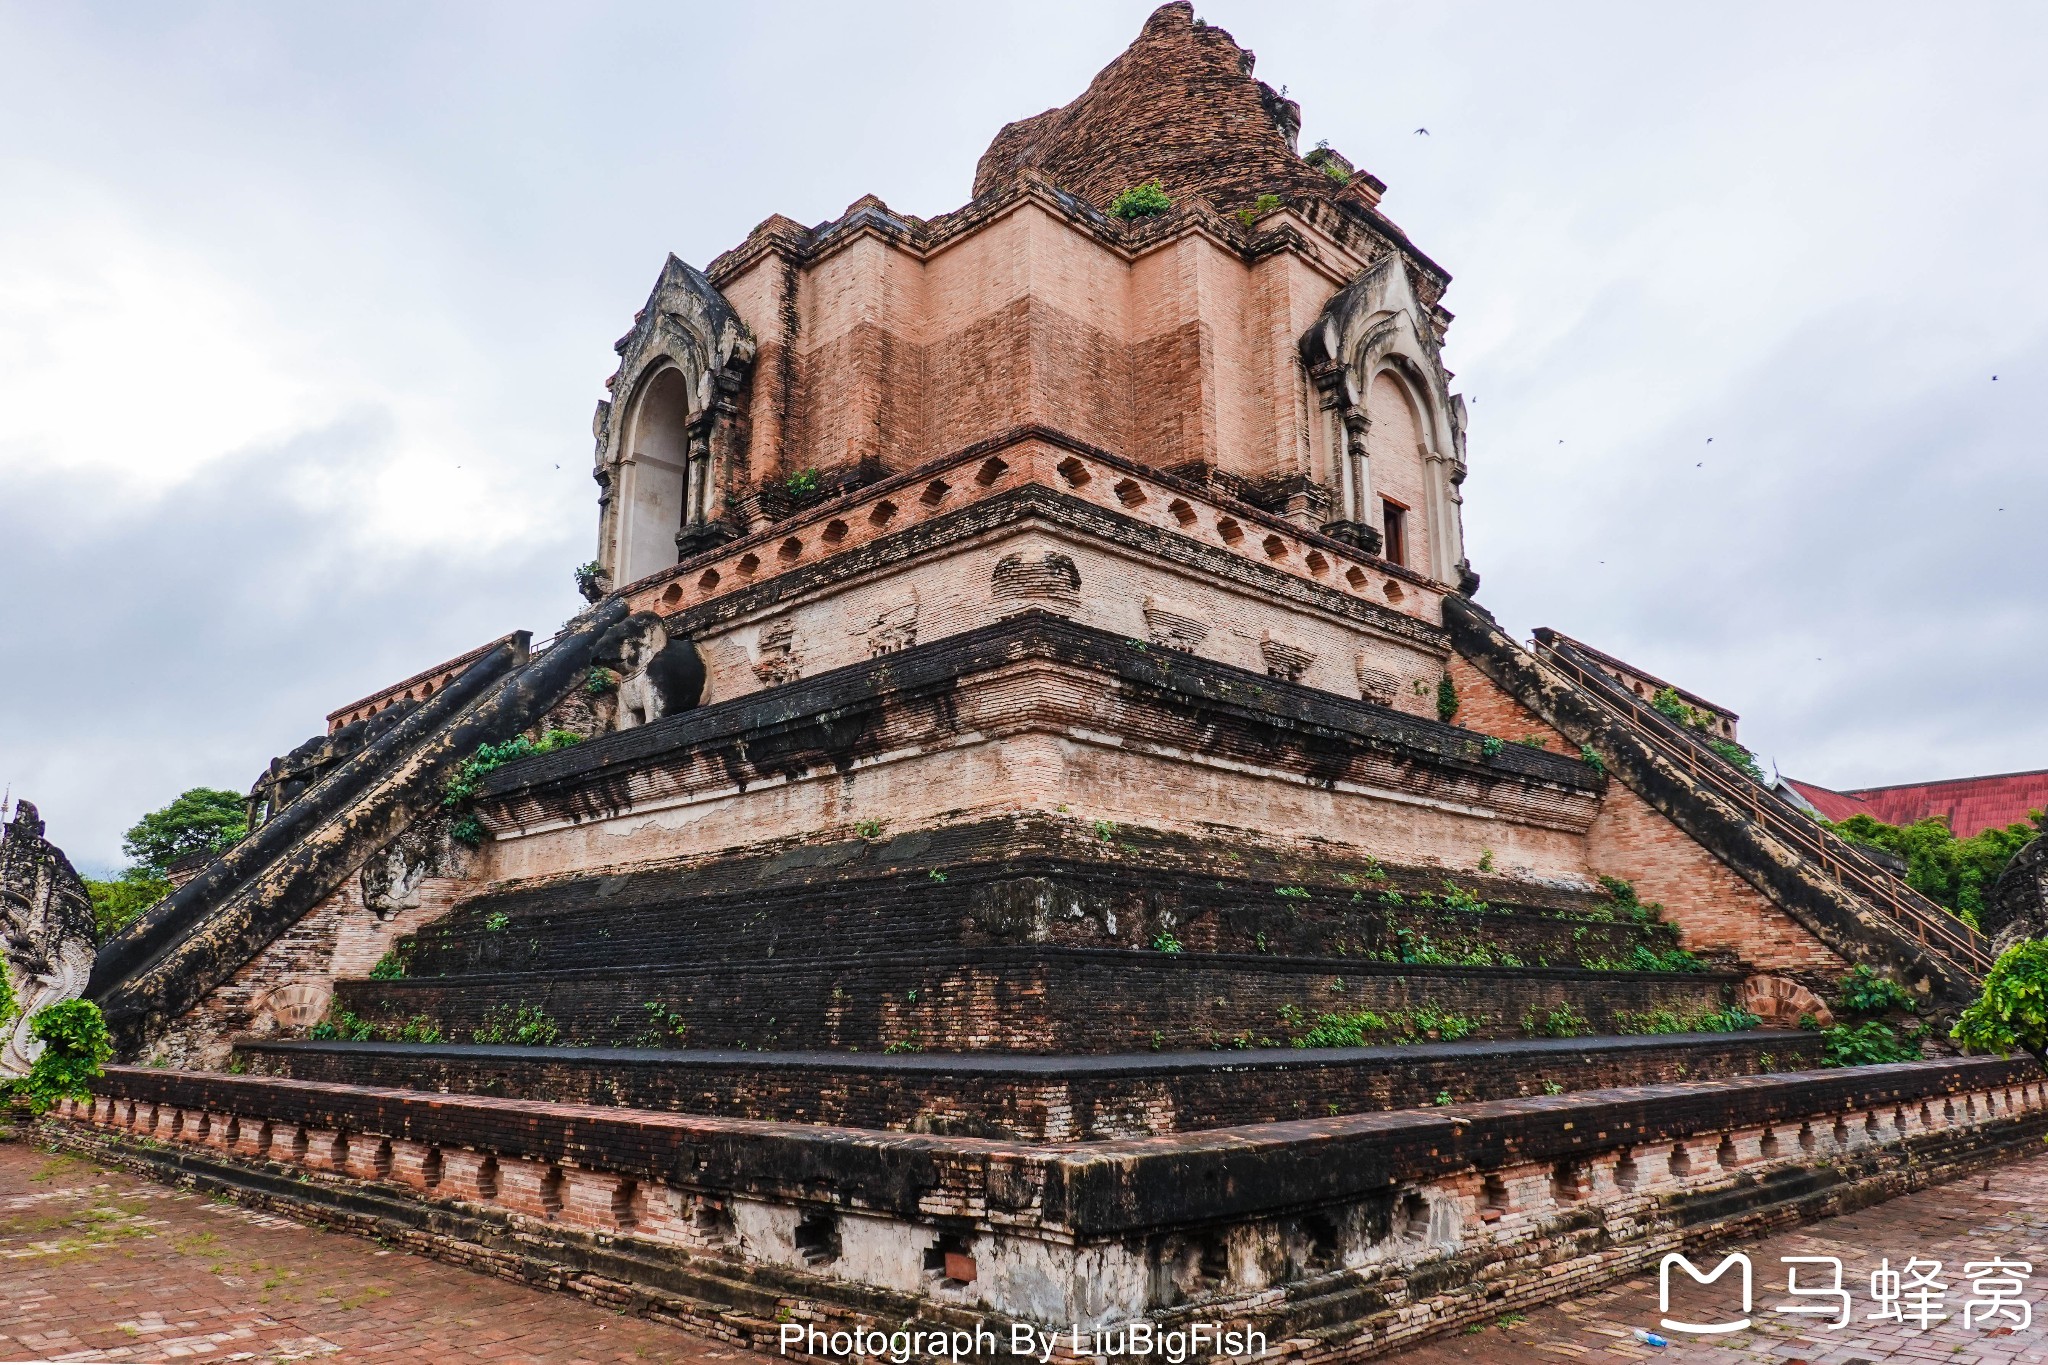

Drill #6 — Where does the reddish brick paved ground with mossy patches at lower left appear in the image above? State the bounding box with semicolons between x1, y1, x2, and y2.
0;1142;766;1365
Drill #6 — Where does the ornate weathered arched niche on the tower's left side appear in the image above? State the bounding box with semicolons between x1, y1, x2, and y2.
594;256;754;585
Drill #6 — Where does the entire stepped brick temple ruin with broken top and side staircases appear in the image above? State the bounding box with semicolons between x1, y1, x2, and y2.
36;4;2048;1361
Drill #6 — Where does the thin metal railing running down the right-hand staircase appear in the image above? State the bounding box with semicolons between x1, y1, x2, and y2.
1536;643;1993;978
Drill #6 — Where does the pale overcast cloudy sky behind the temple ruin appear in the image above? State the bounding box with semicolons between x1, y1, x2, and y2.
0;0;2048;872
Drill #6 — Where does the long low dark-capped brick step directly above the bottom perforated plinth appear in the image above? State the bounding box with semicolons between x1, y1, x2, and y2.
236;1029;1821;1142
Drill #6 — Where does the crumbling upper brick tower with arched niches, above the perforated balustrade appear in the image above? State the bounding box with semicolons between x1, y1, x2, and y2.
596;4;1468;606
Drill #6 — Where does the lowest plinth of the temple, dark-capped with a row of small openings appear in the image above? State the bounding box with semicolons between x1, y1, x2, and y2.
45;1060;2048;1361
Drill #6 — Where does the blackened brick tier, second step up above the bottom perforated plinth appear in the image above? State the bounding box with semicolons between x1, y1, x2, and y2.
336;948;1739;1054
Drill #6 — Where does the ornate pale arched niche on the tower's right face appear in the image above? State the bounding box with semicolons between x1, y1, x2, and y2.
1300;256;1468;585
